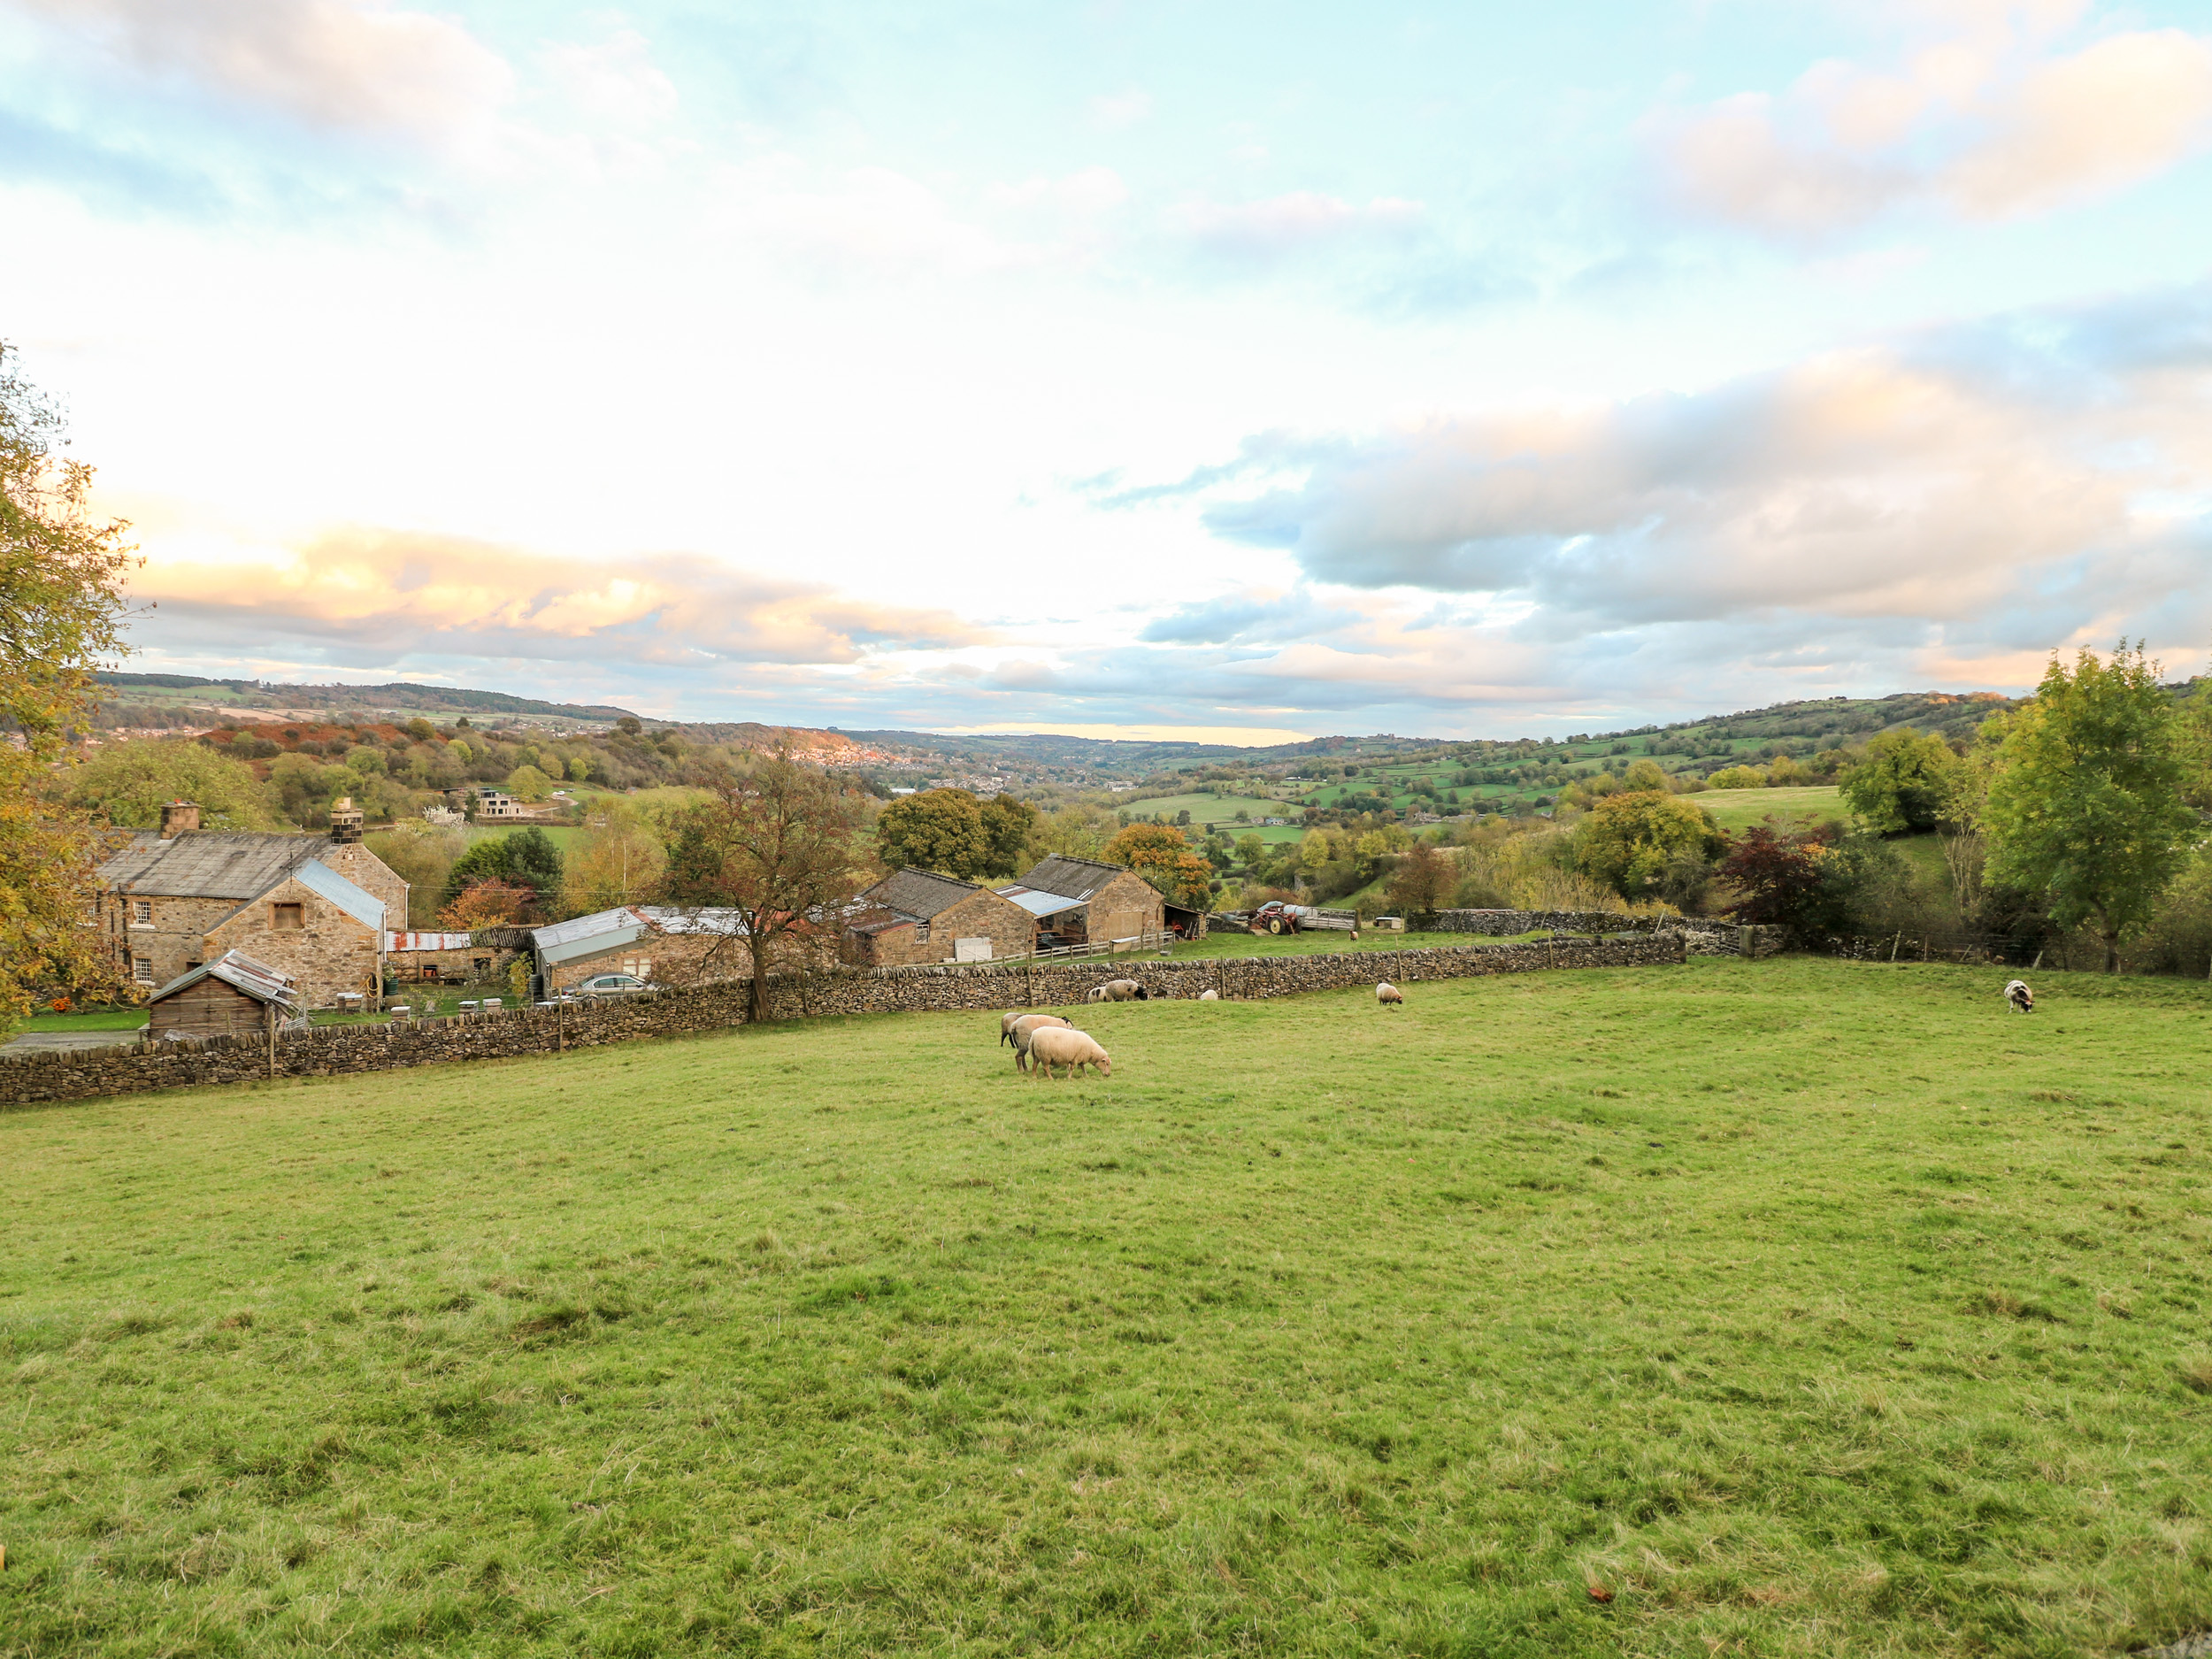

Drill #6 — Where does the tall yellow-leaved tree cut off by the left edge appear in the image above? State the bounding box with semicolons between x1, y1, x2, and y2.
0;345;133;1020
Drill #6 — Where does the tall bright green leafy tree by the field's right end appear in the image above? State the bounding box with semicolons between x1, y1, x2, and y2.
1982;641;2203;973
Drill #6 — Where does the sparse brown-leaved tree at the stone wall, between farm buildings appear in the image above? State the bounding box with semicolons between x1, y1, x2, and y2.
668;750;867;1020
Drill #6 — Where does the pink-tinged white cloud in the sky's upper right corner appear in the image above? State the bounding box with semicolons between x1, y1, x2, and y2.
1655;4;2212;239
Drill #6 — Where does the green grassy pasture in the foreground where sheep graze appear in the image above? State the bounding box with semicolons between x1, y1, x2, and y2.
0;960;2212;1659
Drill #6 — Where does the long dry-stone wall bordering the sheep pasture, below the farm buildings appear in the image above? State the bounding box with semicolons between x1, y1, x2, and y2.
0;933;1684;1109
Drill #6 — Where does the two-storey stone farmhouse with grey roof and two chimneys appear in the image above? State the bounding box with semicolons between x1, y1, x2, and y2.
96;799;407;1009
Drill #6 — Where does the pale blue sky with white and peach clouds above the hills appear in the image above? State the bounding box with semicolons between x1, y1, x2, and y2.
0;0;2212;743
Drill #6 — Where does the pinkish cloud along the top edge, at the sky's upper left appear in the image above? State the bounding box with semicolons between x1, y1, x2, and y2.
12;0;513;137
